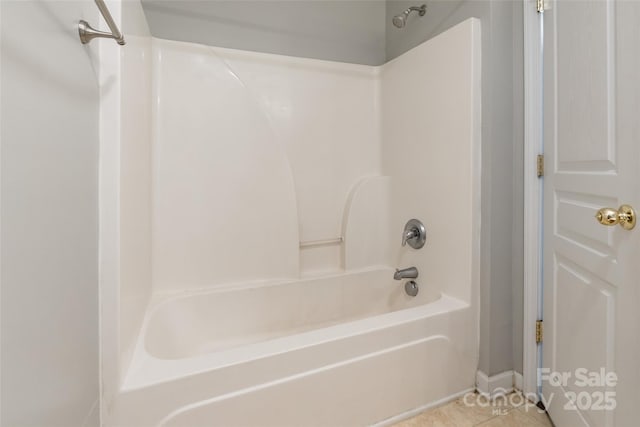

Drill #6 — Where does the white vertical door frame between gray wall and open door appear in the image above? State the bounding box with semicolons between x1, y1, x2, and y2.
522;0;546;403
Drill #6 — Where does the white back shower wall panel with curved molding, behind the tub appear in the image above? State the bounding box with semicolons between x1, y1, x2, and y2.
152;39;381;291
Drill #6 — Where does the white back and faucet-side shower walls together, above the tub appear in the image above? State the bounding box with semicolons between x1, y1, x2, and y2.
152;22;480;301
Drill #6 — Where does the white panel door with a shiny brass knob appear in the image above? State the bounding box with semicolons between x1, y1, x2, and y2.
542;0;640;427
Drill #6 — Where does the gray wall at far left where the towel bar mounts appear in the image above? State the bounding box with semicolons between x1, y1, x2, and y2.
0;1;99;427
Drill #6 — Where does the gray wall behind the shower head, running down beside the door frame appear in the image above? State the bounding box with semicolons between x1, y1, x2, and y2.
386;0;523;375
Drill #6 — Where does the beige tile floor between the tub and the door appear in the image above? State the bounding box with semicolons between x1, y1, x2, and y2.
393;393;553;427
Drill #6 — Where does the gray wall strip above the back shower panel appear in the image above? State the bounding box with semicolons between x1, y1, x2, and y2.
142;0;385;65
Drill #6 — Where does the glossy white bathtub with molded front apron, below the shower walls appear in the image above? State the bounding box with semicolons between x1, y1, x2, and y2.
108;268;477;427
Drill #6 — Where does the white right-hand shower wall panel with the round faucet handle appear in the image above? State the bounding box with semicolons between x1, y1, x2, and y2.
382;19;481;301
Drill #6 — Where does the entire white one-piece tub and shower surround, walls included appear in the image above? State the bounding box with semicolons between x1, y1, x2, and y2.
101;13;480;426
